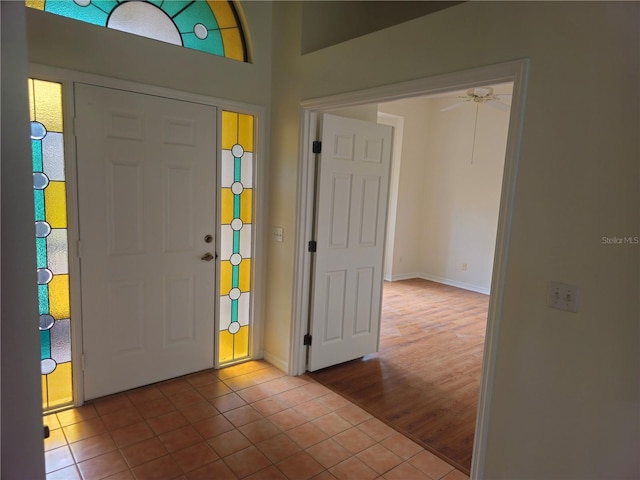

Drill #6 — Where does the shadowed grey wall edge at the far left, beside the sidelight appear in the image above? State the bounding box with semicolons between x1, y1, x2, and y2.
0;2;45;480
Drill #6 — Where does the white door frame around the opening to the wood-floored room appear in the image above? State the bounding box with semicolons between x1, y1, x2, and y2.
289;59;530;478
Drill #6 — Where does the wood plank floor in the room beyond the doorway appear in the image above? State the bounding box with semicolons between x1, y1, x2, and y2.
311;279;489;473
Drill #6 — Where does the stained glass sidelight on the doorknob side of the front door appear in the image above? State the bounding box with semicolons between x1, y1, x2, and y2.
218;111;254;365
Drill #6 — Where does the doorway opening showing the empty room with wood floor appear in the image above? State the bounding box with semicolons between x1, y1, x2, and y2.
312;84;512;472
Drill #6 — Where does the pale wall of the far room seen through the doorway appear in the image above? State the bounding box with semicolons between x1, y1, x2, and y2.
379;91;511;293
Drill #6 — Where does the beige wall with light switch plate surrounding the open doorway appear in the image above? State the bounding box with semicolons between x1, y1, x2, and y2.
266;2;640;479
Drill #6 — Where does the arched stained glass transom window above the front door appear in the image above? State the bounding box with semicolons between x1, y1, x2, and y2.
26;0;249;62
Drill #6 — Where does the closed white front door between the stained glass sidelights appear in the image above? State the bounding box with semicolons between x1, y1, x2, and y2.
75;84;217;399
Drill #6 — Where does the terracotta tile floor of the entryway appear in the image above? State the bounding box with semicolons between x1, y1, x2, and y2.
44;361;468;480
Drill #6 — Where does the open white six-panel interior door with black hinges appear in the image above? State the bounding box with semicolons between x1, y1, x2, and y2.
307;114;392;371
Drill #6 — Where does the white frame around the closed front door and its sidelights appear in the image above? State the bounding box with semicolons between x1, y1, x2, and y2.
28;63;268;407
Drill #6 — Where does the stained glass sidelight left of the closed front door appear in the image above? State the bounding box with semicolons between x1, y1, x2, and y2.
29;79;73;410
